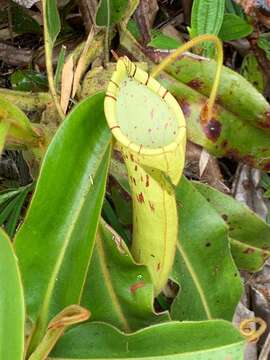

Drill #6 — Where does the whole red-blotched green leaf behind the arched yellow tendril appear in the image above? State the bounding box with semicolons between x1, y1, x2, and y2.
159;55;270;171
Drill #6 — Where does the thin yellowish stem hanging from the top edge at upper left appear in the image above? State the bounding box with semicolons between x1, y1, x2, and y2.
42;0;65;120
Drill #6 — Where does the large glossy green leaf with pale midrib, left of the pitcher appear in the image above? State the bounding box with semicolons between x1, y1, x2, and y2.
15;93;110;352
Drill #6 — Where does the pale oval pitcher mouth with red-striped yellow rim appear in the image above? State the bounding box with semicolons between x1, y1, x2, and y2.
104;57;186;155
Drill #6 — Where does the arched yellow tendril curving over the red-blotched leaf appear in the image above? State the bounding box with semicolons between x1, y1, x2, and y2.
151;34;223;119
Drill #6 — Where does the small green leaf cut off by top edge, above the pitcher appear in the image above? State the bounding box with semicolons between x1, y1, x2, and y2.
96;0;128;26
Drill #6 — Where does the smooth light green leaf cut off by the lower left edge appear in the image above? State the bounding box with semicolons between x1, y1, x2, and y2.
0;229;25;360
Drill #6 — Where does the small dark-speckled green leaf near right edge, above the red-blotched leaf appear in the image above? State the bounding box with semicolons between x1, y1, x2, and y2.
241;54;264;93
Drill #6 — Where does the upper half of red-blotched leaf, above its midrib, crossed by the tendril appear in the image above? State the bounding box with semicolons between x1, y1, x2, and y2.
166;55;270;132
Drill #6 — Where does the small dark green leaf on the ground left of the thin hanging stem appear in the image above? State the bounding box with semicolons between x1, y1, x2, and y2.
10;70;48;92
